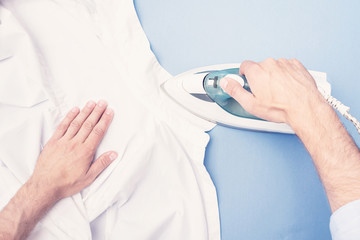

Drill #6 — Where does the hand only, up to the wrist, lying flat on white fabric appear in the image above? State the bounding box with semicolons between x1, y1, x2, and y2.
32;101;117;198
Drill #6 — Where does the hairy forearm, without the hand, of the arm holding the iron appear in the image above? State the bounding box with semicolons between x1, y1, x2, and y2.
291;96;360;211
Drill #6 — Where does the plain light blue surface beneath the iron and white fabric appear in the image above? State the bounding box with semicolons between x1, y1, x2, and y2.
135;0;360;240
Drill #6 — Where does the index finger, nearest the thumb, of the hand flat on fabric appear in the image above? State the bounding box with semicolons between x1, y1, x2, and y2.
85;108;114;149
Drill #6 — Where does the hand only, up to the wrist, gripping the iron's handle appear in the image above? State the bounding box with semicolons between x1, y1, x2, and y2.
220;58;327;125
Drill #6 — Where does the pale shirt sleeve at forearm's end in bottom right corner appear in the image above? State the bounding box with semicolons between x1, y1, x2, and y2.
330;199;360;240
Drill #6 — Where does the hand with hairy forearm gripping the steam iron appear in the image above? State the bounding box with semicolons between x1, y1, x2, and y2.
220;58;360;211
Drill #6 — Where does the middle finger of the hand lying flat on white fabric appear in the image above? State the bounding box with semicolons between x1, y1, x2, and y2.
75;100;107;142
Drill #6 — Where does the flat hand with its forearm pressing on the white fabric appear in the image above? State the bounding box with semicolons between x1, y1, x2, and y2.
0;100;117;240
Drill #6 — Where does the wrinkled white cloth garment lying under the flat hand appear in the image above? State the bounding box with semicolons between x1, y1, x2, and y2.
0;0;220;240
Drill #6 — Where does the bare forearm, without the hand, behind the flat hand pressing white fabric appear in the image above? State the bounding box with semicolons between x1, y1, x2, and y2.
0;178;57;240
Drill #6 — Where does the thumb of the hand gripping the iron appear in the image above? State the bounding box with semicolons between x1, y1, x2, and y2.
220;77;255;112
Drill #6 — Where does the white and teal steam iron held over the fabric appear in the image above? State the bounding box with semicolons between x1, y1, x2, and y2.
162;63;331;134
